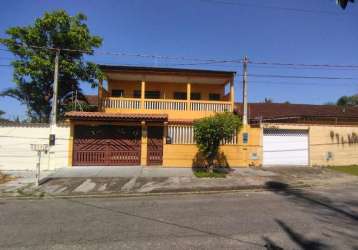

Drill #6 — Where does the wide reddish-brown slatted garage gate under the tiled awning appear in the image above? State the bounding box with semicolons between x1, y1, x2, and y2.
73;126;141;166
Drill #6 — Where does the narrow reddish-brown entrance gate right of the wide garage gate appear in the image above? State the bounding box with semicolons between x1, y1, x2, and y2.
147;126;163;166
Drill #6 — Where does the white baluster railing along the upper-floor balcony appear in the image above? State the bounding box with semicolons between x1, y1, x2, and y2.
103;97;232;112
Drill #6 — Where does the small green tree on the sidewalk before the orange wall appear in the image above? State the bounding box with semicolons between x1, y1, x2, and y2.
194;112;242;172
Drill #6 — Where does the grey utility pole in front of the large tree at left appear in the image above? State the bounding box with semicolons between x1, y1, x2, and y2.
49;49;60;167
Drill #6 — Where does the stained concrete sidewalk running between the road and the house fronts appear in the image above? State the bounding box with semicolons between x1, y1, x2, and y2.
0;166;358;197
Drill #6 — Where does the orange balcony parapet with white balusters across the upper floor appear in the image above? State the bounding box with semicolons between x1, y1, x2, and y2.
102;97;233;119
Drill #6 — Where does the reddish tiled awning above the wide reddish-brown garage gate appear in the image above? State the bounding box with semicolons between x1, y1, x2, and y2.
65;111;168;122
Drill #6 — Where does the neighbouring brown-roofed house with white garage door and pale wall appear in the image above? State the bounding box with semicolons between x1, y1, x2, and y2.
237;103;358;166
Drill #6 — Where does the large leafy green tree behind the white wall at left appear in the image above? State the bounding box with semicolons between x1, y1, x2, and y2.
0;10;102;122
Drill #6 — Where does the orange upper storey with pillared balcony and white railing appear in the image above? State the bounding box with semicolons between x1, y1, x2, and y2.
98;66;235;120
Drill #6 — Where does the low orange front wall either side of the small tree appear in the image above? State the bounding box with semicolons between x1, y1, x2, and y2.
163;127;262;167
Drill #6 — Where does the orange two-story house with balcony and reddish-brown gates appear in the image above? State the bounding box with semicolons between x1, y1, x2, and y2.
67;66;260;167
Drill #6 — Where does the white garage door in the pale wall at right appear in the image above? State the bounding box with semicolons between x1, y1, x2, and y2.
263;129;308;166
